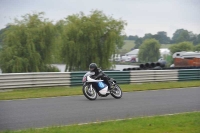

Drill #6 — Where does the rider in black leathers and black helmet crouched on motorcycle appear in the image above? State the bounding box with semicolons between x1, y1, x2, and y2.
89;63;110;89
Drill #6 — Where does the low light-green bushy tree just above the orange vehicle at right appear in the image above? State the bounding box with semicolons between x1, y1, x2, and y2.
169;42;193;54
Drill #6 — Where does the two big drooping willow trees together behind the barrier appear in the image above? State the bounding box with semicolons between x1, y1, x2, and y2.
0;10;126;73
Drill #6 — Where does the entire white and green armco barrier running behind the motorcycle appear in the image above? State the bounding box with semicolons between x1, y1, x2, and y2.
0;69;200;89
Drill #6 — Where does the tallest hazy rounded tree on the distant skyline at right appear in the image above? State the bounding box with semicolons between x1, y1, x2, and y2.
172;29;190;43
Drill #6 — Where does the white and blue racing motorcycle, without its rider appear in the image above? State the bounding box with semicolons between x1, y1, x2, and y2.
82;72;122;100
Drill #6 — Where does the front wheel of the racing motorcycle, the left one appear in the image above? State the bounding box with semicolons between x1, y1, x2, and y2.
83;85;97;100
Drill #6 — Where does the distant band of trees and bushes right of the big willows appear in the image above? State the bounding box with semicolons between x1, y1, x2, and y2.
124;29;200;65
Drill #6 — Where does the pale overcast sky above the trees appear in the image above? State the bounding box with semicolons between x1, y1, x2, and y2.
0;0;200;37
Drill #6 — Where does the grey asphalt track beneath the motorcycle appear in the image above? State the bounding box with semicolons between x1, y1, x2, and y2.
0;88;200;131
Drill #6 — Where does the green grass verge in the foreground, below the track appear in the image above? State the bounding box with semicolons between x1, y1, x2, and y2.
4;112;200;133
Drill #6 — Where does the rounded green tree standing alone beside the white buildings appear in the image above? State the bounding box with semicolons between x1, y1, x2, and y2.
138;39;160;62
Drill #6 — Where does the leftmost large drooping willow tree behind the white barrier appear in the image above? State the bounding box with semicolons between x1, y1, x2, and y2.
0;13;58;73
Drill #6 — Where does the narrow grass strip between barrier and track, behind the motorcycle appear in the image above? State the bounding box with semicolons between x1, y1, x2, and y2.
0;81;200;100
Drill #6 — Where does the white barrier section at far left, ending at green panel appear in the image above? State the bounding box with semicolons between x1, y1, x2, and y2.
0;72;71;89
